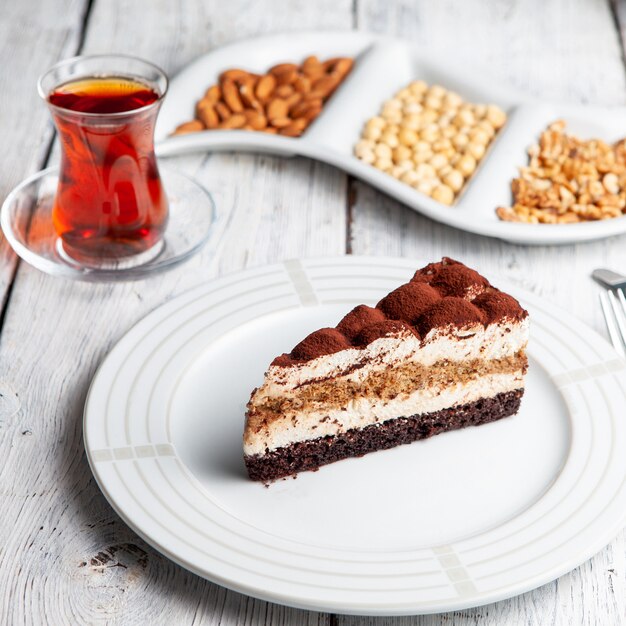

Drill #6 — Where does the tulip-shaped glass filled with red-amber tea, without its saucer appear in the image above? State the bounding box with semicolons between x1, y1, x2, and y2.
38;55;168;267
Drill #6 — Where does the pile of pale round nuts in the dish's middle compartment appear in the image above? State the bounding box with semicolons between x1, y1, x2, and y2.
354;80;506;205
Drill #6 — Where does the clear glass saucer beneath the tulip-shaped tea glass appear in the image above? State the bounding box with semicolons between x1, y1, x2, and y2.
0;165;216;282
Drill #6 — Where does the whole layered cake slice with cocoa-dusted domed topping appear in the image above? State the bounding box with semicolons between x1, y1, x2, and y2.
244;258;528;481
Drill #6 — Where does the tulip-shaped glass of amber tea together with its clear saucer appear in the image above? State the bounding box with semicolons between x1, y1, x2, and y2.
2;55;214;279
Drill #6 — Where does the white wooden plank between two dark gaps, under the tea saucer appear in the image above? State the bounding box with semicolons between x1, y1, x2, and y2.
0;0;352;625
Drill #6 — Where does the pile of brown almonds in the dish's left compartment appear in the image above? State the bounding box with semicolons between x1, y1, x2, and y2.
174;56;353;137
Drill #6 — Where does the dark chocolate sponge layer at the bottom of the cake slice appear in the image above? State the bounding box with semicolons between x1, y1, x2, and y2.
244;389;524;482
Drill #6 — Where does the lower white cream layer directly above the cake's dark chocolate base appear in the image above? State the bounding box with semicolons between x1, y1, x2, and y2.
243;370;524;456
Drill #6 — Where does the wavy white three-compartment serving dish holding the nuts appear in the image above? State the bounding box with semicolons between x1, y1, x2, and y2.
156;31;626;245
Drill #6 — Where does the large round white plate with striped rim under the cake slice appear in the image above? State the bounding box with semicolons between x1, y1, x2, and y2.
84;257;626;615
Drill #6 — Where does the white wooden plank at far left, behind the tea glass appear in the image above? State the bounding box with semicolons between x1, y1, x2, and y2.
0;0;87;318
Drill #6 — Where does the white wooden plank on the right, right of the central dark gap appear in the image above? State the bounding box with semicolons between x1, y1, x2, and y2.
338;0;626;626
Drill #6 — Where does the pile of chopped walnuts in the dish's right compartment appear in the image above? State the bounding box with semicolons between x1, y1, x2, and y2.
496;121;626;224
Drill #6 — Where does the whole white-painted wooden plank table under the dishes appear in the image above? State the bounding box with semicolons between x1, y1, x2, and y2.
0;0;626;626
